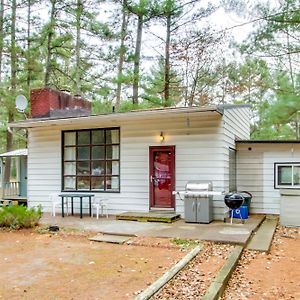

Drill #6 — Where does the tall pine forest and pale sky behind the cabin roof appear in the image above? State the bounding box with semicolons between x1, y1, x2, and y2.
0;0;300;151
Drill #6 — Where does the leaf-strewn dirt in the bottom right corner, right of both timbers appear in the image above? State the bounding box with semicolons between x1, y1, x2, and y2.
222;226;300;300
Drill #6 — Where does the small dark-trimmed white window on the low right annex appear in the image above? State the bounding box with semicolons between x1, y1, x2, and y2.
274;163;300;188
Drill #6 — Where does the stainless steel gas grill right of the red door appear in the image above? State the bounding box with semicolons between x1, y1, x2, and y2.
173;180;222;223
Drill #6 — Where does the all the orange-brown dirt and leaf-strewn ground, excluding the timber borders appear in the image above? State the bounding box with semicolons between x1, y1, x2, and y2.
0;226;300;300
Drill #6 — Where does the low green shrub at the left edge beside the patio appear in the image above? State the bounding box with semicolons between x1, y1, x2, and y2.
0;205;43;229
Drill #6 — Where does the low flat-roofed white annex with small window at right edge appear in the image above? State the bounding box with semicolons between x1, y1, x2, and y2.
237;140;300;226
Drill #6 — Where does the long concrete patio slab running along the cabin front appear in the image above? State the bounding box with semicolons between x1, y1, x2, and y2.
41;214;265;245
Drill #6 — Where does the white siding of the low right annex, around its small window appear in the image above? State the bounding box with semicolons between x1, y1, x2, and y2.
237;143;300;214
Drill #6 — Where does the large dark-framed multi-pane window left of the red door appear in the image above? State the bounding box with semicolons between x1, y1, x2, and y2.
62;128;120;192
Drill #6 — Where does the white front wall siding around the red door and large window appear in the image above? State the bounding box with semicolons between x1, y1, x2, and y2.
28;113;229;218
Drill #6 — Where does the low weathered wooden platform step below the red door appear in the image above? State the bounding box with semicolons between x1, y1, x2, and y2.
116;211;180;223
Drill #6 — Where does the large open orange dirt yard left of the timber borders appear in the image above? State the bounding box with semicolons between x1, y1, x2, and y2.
0;230;188;300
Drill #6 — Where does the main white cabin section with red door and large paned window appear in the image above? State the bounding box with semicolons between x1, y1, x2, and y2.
9;105;250;219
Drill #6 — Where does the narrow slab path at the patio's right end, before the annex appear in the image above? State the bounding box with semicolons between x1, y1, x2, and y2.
247;216;278;252
